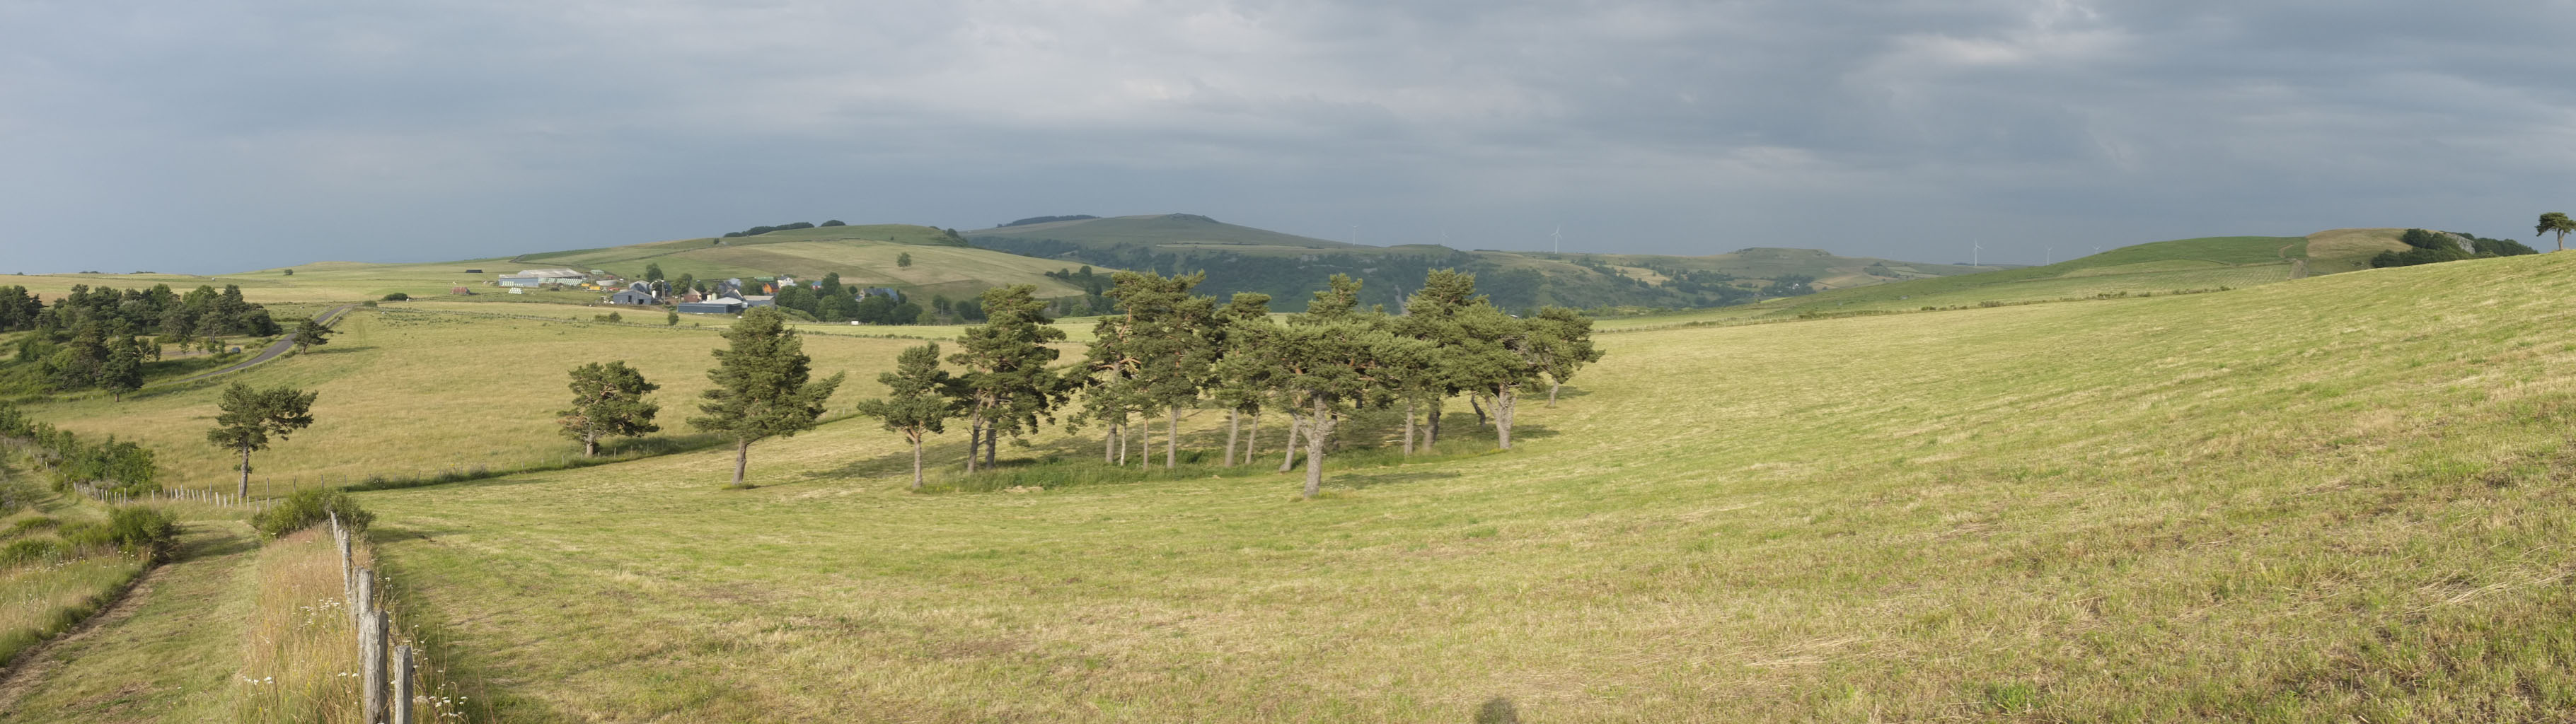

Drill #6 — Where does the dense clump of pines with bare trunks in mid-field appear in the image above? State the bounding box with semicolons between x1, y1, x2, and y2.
857;268;1602;497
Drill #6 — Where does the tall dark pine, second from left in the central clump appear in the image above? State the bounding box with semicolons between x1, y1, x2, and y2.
948;284;1066;472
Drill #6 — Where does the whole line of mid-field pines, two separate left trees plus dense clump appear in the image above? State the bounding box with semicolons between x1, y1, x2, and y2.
559;268;1602;497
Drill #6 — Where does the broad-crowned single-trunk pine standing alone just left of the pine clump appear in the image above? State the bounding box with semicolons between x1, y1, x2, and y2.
688;307;843;487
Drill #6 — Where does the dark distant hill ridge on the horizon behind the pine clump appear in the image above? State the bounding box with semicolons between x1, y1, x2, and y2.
964;214;1997;309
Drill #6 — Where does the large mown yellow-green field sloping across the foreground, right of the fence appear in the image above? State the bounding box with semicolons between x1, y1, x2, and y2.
342;255;2576;721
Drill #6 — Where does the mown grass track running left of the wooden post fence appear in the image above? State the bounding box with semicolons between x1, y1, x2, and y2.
0;520;258;721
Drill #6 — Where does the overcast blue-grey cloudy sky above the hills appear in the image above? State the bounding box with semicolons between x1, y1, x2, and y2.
0;0;2576;273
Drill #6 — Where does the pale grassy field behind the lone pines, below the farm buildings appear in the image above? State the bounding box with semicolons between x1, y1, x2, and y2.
25;304;994;497
